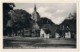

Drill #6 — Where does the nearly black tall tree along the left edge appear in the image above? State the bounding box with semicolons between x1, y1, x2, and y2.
3;3;15;35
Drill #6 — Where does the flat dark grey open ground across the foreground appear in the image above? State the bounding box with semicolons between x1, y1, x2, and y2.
3;37;76;48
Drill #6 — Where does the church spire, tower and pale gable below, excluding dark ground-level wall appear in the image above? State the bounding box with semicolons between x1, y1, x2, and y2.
31;4;40;30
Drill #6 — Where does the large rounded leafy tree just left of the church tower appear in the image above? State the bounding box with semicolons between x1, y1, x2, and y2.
9;9;32;35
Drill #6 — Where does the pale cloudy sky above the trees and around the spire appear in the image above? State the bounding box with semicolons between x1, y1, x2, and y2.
14;3;76;25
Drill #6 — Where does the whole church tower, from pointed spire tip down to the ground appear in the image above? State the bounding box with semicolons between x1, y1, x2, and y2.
31;4;40;37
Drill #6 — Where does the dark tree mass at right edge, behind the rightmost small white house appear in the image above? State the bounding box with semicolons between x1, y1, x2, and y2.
60;13;76;38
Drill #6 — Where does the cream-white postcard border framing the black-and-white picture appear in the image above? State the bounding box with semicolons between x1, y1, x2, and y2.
0;0;80;52
